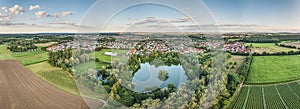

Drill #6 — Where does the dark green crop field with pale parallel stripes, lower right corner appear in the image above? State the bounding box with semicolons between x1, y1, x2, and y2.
231;81;300;109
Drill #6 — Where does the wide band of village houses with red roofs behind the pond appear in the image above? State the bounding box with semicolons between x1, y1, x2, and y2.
46;34;250;56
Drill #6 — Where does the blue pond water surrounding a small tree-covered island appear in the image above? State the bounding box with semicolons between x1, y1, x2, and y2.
132;63;187;92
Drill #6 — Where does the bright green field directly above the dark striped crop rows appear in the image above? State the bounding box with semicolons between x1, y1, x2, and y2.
246;55;300;84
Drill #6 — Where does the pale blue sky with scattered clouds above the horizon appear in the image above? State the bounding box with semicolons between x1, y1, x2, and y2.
0;0;300;33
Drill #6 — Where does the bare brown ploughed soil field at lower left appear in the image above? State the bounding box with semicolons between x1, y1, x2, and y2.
0;60;101;109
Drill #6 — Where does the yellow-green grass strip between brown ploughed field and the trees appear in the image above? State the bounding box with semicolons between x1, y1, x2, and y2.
26;62;79;94
